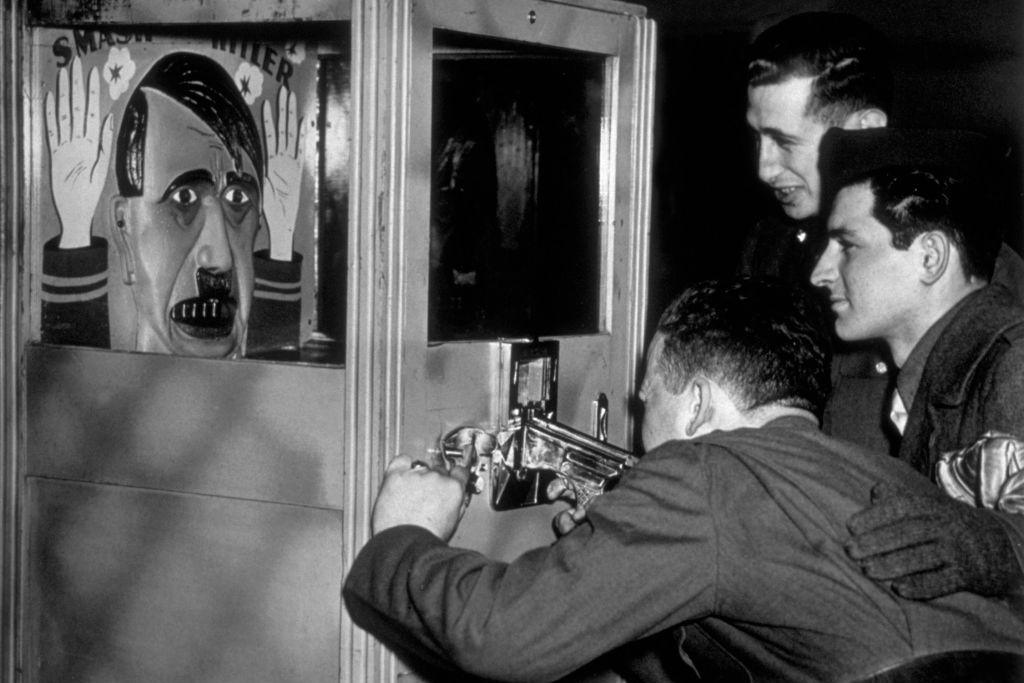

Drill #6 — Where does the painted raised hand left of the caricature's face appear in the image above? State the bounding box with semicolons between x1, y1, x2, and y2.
44;57;114;249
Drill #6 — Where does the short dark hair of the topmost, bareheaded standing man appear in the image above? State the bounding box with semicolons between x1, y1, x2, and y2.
746;12;893;125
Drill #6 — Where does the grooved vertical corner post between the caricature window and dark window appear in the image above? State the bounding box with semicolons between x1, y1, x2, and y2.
341;0;412;683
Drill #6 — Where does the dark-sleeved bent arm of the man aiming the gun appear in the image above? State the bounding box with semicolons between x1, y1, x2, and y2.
344;454;715;681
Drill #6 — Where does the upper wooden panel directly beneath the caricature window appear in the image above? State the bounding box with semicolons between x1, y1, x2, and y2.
26;346;344;508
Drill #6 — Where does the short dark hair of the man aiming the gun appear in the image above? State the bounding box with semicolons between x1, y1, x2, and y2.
657;278;831;417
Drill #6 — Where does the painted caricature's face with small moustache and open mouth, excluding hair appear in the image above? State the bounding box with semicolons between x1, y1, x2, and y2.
116;90;260;357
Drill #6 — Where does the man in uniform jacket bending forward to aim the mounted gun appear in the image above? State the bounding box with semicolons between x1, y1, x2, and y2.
344;280;1024;681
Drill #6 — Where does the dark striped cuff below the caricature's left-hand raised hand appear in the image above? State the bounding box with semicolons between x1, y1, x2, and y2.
40;237;111;348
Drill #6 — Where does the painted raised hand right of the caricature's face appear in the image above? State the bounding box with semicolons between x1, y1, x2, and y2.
263;86;306;261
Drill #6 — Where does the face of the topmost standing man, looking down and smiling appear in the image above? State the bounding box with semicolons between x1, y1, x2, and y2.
746;76;830;219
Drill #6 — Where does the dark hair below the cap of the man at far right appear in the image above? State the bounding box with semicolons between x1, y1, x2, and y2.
860;166;1001;282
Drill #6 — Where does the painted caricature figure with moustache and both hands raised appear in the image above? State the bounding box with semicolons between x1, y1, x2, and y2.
41;48;306;357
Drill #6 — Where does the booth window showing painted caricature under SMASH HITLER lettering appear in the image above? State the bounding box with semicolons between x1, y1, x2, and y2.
33;22;350;364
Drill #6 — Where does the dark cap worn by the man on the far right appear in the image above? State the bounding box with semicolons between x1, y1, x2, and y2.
818;128;1006;215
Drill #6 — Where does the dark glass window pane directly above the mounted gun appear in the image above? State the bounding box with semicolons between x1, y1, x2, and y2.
429;31;604;341
